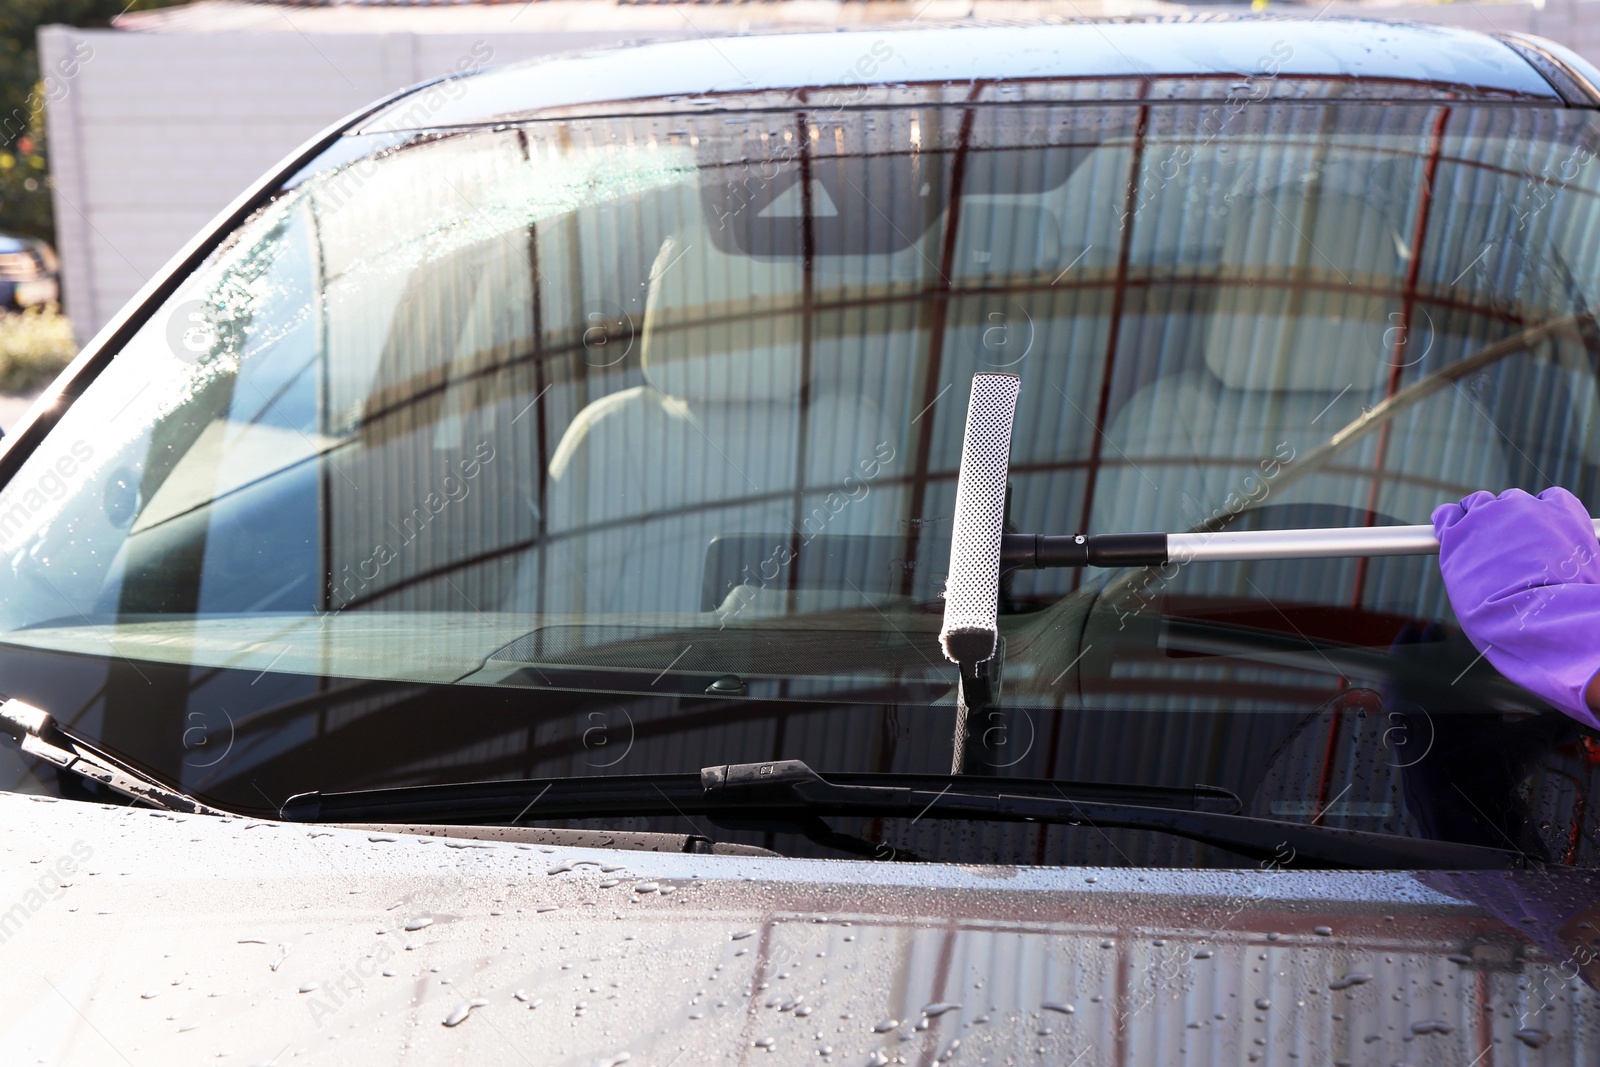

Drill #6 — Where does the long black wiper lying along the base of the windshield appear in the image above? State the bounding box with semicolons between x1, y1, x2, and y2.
280;760;1530;870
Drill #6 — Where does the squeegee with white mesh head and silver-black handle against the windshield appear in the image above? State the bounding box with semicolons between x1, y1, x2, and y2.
939;374;1600;749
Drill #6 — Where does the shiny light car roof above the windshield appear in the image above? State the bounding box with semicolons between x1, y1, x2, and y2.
360;18;1563;133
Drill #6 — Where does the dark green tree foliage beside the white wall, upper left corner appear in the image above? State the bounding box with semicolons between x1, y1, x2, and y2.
0;0;187;245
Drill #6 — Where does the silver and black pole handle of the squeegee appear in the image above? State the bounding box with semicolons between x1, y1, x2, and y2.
1000;520;1600;569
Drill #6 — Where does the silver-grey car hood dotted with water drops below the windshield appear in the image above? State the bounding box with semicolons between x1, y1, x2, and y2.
0;793;1600;1067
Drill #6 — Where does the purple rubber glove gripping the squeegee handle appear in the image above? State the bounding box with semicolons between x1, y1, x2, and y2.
1434;488;1600;729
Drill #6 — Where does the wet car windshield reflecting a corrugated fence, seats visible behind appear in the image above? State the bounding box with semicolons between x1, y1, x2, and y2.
0;78;1600;865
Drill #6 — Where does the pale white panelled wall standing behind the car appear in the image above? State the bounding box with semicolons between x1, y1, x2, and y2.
37;0;1600;342
